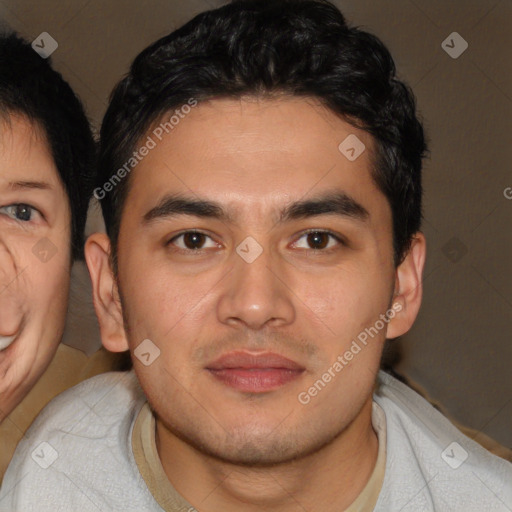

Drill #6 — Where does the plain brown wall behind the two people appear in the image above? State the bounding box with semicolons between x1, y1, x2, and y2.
0;0;512;447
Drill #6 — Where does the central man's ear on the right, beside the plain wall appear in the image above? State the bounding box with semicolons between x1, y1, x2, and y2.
386;232;427;339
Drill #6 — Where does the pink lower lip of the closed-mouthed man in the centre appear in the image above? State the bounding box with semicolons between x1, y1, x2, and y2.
208;368;304;393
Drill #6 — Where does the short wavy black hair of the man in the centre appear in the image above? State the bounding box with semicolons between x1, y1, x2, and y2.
97;0;427;269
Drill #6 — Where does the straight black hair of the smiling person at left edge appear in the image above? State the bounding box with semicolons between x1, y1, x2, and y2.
0;33;96;259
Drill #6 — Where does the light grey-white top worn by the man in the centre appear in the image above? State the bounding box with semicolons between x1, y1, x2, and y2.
0;372;512;512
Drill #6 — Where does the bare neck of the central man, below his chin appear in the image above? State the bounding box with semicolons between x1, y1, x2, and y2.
156;397;378;512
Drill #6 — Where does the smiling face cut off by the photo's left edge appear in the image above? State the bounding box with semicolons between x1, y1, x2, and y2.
0;115;71;421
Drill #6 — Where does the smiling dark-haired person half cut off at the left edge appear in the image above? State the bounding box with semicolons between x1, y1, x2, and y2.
0;34;120;480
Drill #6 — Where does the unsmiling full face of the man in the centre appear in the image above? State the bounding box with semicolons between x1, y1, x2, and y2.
88;98;404;464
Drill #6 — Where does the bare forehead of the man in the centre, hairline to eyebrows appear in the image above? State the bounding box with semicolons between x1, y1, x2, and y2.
129;98;382;221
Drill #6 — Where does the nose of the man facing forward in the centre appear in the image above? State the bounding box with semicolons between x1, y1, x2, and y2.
217;243;296;330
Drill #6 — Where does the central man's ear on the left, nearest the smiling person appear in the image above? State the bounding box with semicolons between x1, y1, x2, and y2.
85;233;128;352
